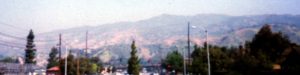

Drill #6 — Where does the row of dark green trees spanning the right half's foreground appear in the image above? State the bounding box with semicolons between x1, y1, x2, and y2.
163;25;300;75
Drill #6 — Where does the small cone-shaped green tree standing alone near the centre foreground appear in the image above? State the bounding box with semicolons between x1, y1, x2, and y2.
127;41;140;75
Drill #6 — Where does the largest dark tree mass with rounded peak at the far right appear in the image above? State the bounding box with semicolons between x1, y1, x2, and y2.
233;24;300;75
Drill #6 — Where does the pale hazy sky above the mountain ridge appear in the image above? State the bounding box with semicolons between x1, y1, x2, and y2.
0;0;300;33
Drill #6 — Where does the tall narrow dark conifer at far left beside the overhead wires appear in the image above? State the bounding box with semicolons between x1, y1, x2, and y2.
25;30;36;64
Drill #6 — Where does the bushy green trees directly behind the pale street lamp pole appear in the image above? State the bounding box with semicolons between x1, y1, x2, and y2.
191;43;233;74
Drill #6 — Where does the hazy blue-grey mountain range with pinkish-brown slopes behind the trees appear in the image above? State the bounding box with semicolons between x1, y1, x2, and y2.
1;14;300;66
